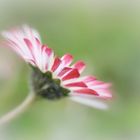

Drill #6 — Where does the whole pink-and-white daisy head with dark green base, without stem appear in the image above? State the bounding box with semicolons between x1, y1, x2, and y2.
2;25;112;109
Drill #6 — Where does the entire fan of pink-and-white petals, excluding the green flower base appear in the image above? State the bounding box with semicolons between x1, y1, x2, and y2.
2;25;112;109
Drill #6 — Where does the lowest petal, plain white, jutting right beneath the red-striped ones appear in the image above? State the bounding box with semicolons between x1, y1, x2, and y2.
70;95;108;110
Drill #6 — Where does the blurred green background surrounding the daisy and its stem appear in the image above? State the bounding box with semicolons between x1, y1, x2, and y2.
0;0;140;140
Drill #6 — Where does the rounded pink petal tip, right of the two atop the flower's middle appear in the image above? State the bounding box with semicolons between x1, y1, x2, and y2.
72;61;86;73
